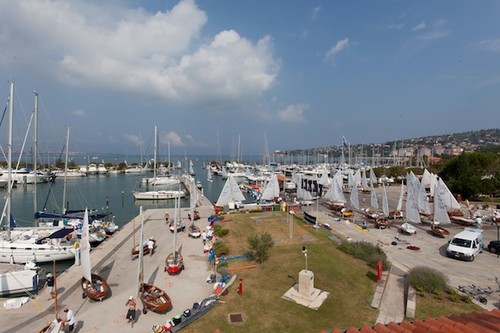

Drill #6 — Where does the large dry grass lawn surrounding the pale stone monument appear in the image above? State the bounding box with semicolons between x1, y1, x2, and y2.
183;212;378;332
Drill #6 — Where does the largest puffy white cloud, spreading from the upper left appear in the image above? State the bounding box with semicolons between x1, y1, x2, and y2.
0;0;279;103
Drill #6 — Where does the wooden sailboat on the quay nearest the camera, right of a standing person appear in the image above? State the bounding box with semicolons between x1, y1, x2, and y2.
137;206;172;314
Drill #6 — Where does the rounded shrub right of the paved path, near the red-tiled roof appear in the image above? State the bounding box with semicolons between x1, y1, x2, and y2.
408;266;448;295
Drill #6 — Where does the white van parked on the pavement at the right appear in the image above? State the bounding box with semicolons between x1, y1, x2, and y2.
446;228;484;261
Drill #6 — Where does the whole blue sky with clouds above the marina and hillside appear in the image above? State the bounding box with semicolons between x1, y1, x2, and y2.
0;0;500;158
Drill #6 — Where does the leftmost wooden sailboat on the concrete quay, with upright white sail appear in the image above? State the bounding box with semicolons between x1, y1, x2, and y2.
80;210;111;301
